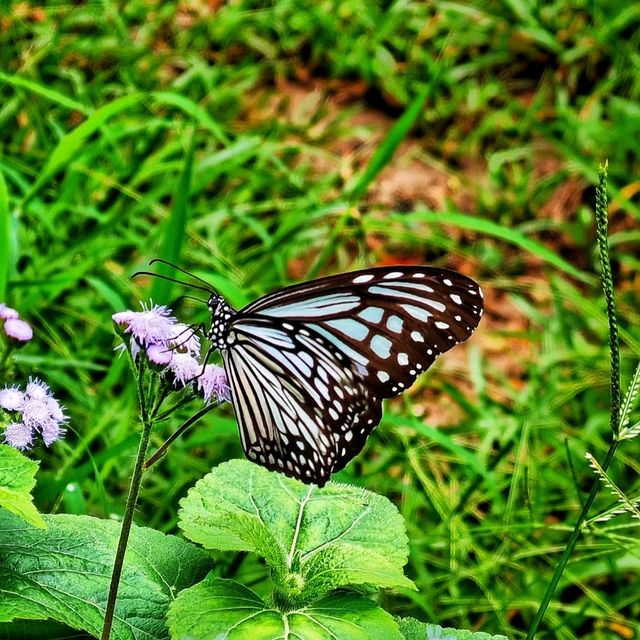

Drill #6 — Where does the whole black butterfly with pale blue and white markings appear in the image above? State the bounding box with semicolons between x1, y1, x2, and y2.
146;260;483;486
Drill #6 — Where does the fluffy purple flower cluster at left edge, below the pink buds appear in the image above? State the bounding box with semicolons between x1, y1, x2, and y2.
0;378;67;450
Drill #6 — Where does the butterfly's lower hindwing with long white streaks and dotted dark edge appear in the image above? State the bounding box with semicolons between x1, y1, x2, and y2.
222;315;381;486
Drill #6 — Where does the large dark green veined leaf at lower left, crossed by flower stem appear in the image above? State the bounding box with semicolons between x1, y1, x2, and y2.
0;511;210;640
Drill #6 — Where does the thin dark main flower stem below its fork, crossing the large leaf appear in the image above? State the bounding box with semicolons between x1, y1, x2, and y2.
100;412;153;640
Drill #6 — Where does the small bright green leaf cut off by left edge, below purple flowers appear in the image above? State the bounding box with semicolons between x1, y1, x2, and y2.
0;444;45;528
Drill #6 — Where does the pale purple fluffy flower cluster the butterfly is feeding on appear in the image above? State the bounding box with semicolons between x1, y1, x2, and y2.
112;303;231;402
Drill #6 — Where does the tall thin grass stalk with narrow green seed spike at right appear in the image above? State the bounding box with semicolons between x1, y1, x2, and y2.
526;164;620;640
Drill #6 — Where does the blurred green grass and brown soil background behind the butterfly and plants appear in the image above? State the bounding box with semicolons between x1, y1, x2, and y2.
0;0;640;640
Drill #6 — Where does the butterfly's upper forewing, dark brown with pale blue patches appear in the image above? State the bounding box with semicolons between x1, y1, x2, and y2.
240;266;483;398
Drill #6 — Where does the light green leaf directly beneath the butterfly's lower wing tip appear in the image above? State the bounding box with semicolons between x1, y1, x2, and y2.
179;460;414;606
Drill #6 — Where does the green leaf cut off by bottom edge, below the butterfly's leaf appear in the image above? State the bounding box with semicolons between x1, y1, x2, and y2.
168;575;402;640
